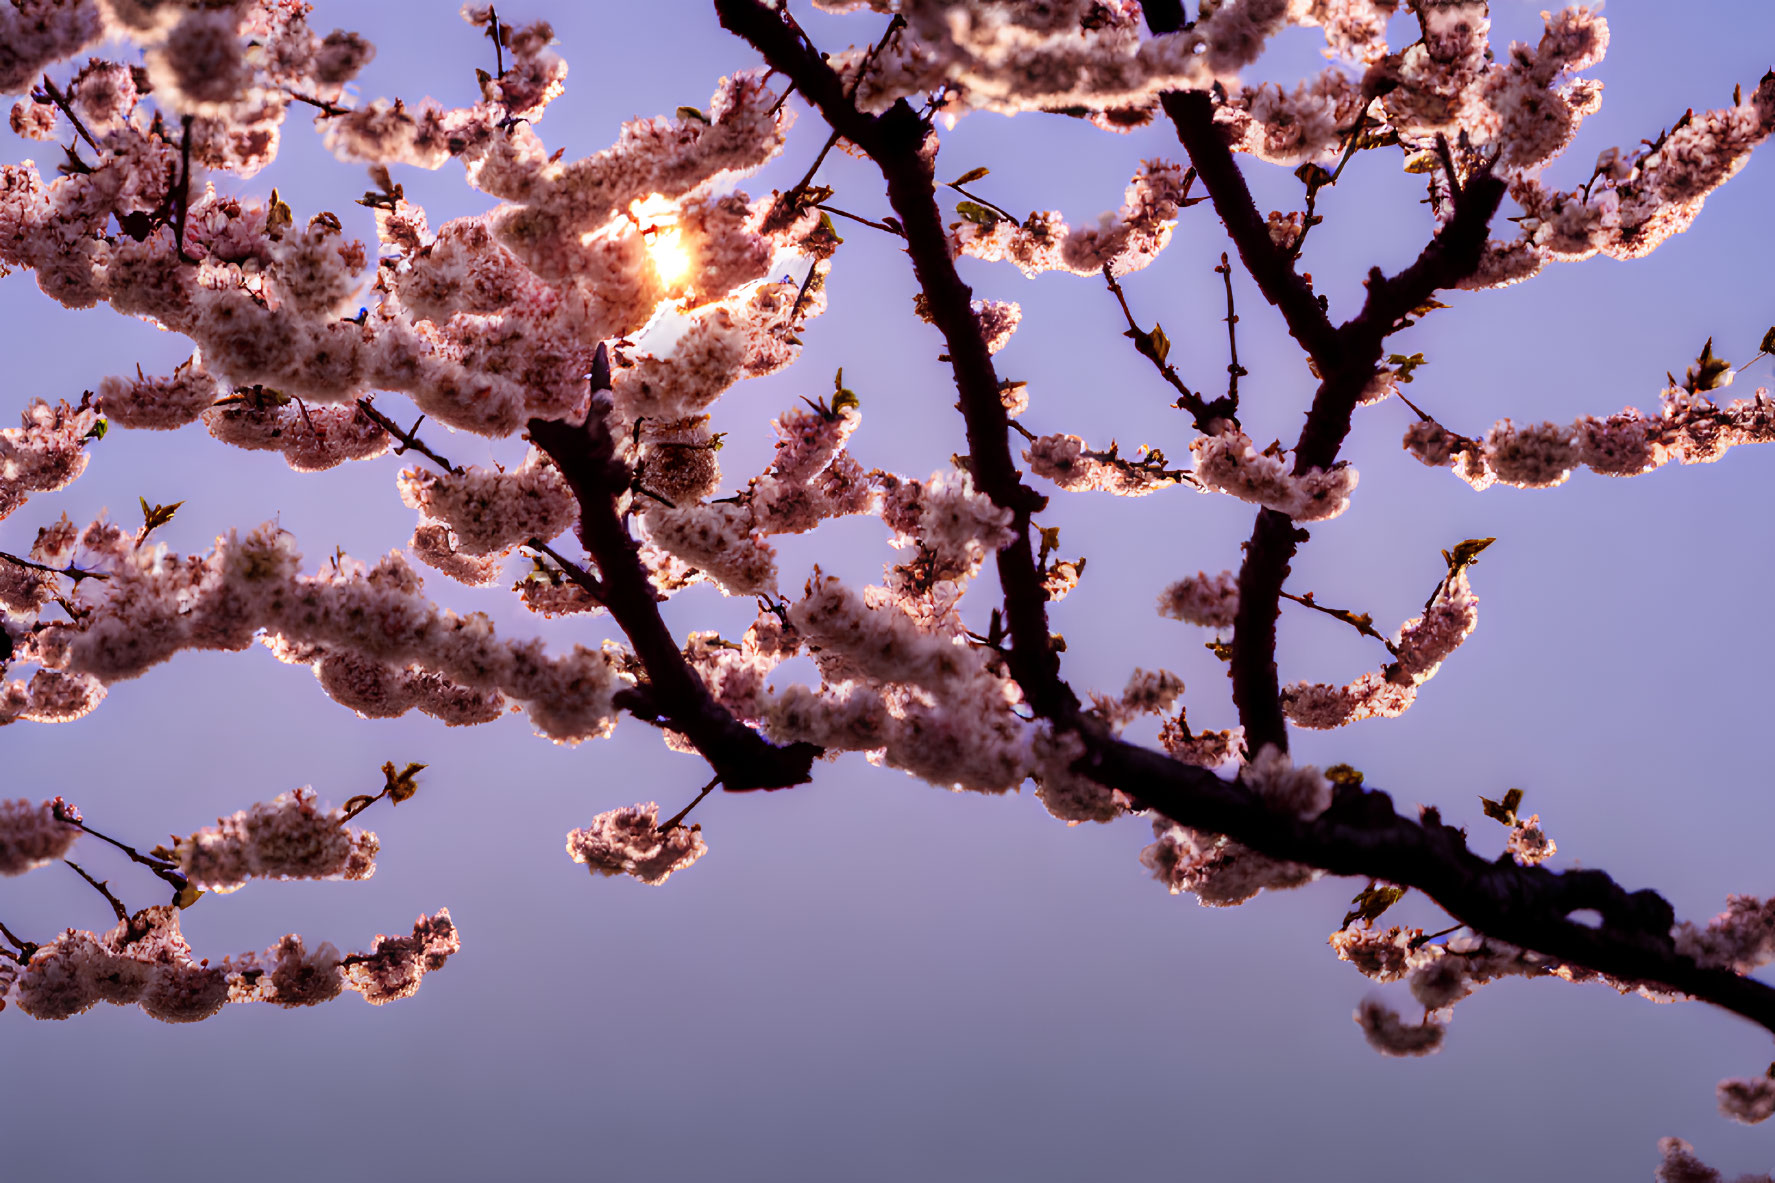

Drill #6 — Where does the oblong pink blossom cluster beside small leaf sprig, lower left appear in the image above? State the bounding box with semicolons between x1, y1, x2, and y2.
172;787;382;892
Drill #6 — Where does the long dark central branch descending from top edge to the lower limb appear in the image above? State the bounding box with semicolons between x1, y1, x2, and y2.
715;0;1077;719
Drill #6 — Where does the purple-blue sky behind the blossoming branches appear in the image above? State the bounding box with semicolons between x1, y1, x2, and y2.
0;0;1775;1183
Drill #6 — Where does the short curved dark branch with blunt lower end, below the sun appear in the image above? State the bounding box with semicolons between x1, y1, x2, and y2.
529;345;820;790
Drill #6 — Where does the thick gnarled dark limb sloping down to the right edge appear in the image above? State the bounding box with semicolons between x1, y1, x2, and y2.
1079;735;1775;1032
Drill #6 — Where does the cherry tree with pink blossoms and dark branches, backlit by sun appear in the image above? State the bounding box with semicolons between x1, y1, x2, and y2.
0;0;1775;1179
